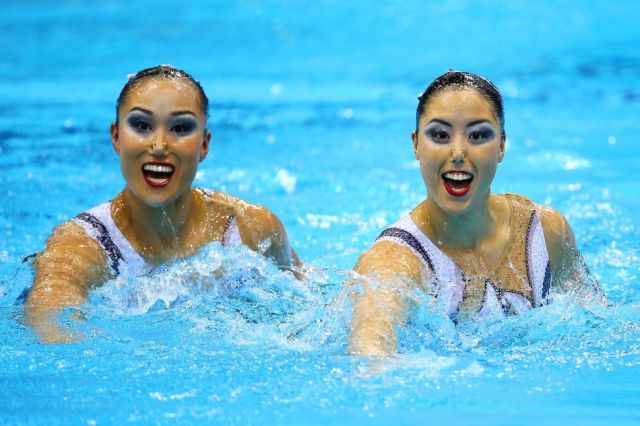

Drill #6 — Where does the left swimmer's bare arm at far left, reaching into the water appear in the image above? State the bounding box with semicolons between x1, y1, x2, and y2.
25;223;108;342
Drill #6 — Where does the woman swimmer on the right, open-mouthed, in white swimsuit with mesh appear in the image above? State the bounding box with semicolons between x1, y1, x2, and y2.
350;71;599;355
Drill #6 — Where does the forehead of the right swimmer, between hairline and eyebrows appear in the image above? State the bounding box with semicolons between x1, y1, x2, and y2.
422;88;499;123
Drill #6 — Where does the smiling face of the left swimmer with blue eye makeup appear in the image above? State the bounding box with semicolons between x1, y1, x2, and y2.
111;78;211;207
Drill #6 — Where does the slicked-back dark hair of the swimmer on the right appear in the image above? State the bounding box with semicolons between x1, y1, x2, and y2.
416;70;504;134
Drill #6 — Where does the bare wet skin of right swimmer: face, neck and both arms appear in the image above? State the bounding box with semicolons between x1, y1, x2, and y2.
350;87;597;356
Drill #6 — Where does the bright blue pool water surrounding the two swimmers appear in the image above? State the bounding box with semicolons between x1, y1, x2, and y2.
0;0;640;424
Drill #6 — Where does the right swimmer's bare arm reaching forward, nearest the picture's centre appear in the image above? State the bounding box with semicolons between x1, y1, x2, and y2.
349;241;423;356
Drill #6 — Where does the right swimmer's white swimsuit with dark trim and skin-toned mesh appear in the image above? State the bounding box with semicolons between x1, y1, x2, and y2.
374;194;551;319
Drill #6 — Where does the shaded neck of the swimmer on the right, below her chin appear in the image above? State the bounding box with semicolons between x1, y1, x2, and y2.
423;194;496;249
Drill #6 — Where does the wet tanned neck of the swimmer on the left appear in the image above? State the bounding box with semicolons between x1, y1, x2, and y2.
114;188;193;251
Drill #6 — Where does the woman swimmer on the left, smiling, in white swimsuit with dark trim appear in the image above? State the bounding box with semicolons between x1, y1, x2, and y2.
25;65;300;341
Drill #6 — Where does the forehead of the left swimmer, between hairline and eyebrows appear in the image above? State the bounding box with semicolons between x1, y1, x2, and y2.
122;77;202;113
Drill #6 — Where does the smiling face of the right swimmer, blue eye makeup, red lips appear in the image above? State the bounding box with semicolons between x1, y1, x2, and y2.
411;88;505;215
